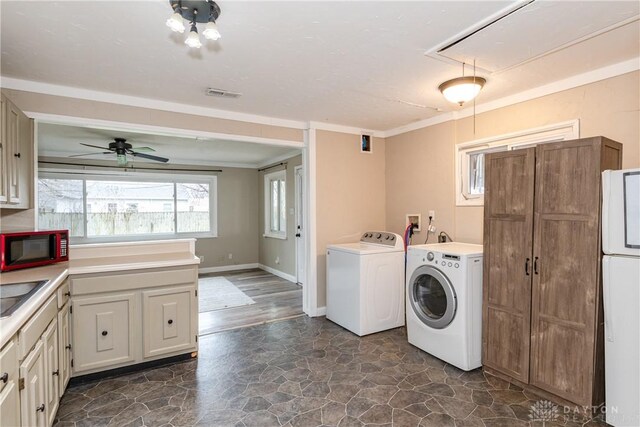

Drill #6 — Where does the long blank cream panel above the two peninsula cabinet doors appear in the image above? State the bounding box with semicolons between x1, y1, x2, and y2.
71;266;198;297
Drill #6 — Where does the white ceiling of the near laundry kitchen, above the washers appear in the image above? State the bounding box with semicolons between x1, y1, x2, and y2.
0;0;640;130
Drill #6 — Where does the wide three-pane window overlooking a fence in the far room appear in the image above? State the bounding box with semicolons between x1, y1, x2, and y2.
38;171;217;243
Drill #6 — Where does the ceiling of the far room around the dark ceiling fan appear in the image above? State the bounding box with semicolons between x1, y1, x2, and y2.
38;123;300;168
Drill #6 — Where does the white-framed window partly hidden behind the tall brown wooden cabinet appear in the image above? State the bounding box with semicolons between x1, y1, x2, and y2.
456;120;580;206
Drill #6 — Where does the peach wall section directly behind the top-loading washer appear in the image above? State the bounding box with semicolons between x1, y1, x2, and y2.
316;131;385;307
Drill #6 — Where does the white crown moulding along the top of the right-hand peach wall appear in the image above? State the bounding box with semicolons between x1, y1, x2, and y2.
381;57;640;138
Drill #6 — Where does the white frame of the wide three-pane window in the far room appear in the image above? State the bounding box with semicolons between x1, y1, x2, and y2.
35;168;218;244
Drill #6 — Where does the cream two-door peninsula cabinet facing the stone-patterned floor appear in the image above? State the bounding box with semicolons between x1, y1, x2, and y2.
71;265;198;376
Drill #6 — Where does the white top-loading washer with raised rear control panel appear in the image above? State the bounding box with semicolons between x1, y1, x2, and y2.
327;231;404;336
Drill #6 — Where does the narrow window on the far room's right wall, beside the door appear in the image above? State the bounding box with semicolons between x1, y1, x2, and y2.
264;170;287;239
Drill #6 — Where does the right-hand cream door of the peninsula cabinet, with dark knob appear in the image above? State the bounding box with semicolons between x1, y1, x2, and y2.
142;286;198;358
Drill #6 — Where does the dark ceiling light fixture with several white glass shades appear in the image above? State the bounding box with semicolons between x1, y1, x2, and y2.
166;0;221;48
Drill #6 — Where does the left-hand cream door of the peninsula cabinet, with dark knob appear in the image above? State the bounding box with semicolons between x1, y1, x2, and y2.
73;293;135;372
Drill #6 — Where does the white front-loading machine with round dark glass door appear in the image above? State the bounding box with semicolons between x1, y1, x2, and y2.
407;242;482;371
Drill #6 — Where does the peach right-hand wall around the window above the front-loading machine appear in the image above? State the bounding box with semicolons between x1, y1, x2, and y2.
386;72;640;243
